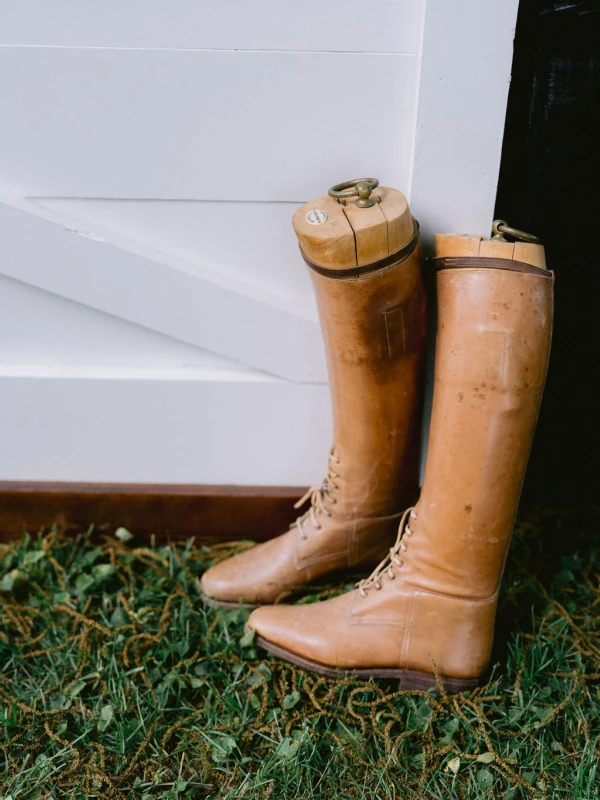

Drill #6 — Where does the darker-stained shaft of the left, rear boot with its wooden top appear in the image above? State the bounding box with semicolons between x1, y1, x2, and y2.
294;187;426;519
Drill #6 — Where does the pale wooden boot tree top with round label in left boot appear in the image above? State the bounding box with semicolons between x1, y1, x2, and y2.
292;186;414;270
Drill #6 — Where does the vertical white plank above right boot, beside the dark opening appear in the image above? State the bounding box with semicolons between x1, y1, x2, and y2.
411;0;518;238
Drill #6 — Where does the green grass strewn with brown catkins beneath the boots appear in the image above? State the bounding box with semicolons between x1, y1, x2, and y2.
0;509;600;800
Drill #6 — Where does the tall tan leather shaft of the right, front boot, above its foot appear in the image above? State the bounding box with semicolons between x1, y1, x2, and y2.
407;237;553;600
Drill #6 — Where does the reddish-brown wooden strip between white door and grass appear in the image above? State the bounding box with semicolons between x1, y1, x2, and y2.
0;481;305;542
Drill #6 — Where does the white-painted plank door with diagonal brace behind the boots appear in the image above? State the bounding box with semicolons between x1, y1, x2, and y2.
0;0;517;485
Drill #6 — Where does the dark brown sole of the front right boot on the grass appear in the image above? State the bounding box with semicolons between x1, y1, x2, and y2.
253;628;480;694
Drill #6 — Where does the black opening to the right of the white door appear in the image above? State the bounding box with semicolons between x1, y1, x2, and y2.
496;0;600;505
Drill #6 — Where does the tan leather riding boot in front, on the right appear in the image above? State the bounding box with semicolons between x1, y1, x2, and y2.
248;228;553;691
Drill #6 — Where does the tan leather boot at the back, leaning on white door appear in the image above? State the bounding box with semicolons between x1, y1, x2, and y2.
202;181;426;607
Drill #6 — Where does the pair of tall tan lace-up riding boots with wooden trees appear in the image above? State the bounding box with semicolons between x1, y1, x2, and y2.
202;187;553;691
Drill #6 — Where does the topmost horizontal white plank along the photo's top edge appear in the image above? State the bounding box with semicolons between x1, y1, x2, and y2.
0;0;423;53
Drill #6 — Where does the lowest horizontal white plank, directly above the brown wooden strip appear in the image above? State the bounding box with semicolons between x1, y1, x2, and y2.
0;369;331;486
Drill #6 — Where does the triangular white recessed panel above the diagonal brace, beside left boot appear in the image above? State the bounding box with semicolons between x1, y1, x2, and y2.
38;199;317;310
